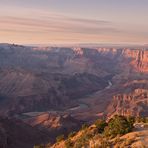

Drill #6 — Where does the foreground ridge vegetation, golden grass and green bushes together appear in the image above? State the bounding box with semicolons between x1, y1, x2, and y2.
34;115;148;148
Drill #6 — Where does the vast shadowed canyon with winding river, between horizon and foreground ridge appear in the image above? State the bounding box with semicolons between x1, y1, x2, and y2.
0;44;148;147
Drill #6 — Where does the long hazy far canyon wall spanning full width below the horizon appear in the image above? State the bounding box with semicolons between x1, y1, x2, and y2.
0;45;148;75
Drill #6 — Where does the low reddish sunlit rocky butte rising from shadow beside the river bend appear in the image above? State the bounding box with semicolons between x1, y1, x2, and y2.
24;112;83;138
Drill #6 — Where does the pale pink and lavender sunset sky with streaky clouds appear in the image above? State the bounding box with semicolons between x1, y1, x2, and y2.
0;0;148;44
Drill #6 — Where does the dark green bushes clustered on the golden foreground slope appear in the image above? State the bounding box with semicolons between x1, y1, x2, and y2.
56;115;138;148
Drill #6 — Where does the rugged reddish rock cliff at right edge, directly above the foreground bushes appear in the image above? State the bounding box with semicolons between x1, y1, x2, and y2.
107;81;148;118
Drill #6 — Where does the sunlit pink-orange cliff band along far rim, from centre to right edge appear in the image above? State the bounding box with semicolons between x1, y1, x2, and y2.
74;48;148;72
